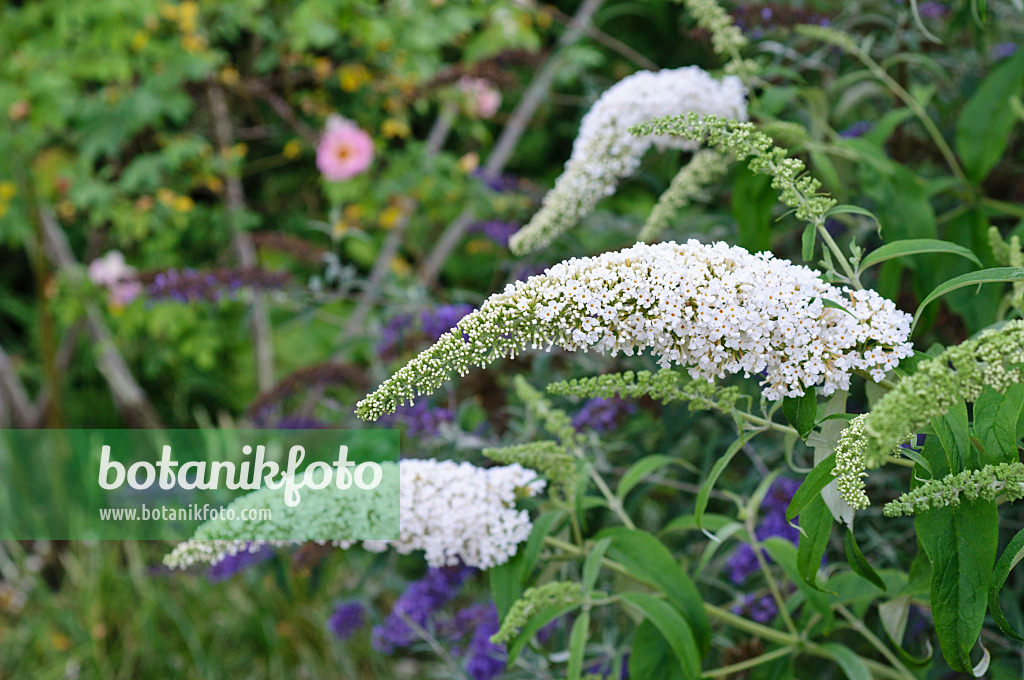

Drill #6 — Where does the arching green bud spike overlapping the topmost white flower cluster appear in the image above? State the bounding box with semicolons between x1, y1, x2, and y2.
630;113;836;232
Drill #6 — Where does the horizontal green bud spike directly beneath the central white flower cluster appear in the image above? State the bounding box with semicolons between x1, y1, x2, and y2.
548;369;741;413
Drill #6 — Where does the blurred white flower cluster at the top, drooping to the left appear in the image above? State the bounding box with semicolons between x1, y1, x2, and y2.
509;67;746;255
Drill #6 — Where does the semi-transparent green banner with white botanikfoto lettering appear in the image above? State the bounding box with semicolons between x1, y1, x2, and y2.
0;429;399;541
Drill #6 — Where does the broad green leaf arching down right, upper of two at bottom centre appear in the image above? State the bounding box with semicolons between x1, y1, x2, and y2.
596;526;711;653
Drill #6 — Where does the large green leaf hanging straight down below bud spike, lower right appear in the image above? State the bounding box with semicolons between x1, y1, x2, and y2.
914;500;998;673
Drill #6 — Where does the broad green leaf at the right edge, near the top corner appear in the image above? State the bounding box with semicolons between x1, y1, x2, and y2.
955;52;1024;182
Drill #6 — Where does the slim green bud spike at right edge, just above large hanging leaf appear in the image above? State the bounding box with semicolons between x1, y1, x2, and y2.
884;463;1024;517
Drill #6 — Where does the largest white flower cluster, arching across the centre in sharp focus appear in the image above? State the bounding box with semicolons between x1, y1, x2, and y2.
356;240;912;420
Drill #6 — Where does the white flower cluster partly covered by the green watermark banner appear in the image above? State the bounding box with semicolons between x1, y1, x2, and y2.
164;459;546;569
